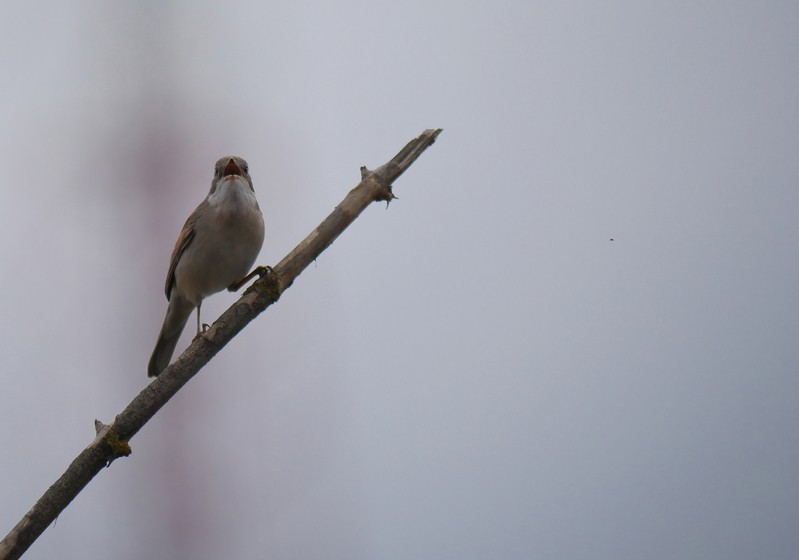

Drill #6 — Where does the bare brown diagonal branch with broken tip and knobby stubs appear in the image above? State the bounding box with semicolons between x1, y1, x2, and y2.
0;129;441;560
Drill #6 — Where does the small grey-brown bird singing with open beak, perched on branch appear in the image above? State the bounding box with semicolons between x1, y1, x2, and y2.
147;156;264;377
